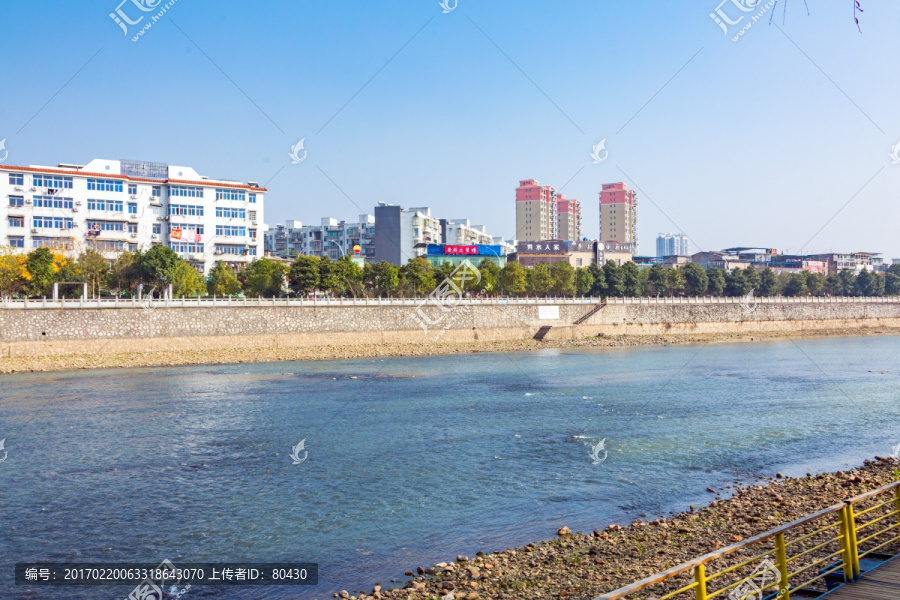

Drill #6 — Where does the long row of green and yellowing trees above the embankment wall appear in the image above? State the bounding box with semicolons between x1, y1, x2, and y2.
0;245;900;298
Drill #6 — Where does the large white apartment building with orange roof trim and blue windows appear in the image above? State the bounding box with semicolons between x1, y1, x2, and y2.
0;159;267;273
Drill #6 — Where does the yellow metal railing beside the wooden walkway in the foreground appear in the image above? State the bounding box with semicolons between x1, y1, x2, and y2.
595;482;900;600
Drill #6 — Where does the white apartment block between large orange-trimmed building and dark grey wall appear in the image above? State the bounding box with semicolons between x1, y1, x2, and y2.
266;214;375;261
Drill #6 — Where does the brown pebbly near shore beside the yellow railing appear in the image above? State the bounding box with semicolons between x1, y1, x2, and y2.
334;458;900;600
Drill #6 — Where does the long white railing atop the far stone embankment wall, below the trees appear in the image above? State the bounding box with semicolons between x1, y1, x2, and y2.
0;296;900;310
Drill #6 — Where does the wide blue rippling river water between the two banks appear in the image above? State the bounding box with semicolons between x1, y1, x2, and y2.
0;337;900;600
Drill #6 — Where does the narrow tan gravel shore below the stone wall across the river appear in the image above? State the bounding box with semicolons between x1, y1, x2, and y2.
0;327;900;374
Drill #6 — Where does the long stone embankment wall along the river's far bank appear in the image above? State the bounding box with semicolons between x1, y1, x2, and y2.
0;298;900;357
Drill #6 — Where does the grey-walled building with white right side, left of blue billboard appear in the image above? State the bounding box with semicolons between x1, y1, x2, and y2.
373;202;443;266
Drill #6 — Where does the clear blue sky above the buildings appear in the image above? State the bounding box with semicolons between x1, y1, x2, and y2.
0;0;900;258
